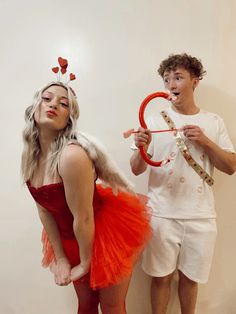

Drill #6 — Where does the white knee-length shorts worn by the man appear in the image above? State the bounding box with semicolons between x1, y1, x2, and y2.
142;216;217;283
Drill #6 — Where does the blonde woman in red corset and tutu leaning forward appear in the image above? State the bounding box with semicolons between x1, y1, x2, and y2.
22;82;150;314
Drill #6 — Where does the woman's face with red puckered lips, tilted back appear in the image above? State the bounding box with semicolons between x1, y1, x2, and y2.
34;85;70;131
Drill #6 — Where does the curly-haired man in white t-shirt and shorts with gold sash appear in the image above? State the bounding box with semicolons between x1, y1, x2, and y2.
130;53;236;314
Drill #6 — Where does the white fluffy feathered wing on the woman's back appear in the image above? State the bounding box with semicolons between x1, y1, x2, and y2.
77;132;134;194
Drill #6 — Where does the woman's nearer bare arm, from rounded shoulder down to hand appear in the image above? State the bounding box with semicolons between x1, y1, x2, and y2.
59;145;94;280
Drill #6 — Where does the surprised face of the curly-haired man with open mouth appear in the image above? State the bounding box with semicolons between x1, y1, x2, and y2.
163;68;199;106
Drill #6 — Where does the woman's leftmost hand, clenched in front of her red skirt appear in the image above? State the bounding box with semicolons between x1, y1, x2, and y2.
50;257;71;286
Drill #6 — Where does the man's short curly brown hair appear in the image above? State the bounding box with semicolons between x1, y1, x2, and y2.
158;53;206;80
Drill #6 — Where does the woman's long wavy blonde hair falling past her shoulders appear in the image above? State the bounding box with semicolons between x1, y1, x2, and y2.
21;82;79;182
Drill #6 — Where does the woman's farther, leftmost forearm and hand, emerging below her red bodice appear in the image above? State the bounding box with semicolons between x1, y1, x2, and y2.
37;204;71;286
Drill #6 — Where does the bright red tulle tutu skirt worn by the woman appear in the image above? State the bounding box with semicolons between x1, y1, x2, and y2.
42;185;151;289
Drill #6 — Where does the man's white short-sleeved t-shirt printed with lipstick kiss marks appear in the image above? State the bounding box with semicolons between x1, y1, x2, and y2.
133;107;234;219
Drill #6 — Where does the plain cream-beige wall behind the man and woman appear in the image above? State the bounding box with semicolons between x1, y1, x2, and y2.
0;0;236;314
